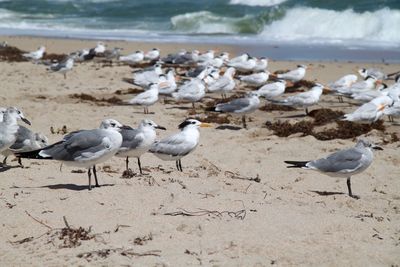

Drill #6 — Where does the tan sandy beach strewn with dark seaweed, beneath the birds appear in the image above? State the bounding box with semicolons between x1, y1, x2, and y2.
0;36;400;266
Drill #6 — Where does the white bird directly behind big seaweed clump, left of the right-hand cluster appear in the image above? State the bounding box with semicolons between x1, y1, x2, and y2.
273;83;324;115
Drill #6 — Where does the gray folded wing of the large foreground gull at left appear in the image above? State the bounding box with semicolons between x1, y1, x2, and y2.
40;129;106;161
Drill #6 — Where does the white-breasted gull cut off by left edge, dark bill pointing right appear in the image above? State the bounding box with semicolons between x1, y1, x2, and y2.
0;107;31;156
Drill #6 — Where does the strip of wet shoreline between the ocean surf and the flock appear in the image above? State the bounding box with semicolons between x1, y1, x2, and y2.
0;31;400;64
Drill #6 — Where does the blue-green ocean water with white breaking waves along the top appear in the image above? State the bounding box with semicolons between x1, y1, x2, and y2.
0;0;400;60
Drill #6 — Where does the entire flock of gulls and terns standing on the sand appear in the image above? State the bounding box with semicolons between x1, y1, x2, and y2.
0;42;400;198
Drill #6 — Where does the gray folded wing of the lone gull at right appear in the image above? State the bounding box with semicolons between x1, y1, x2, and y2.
307;148;363;172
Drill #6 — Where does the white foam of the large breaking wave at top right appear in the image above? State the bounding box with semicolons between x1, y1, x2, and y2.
260;7;400;46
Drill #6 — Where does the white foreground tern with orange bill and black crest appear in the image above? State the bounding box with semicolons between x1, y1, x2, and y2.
149;119;211;171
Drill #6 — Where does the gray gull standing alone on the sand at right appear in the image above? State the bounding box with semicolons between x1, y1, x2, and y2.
285;139;382;198
